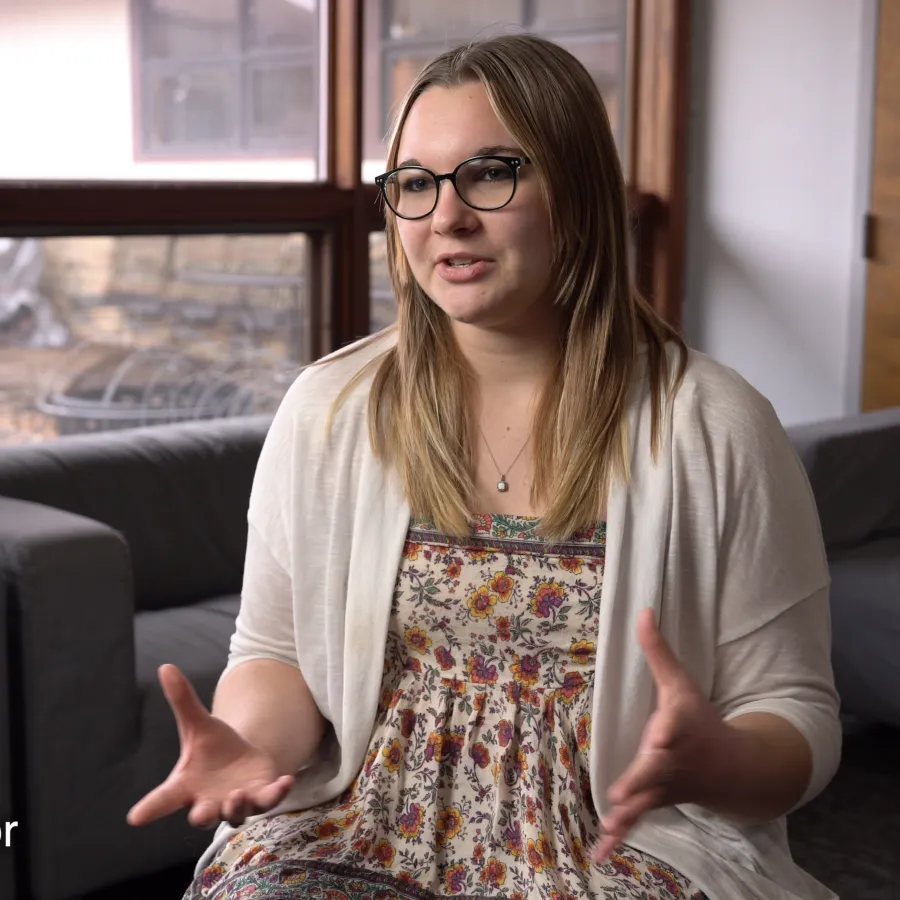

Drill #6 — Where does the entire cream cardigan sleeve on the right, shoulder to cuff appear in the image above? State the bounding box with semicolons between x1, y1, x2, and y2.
682;356;841;803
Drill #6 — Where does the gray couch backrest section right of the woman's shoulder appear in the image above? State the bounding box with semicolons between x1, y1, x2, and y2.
788;407;900;555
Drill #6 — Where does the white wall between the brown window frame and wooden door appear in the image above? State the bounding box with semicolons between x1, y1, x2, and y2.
685;0;876;425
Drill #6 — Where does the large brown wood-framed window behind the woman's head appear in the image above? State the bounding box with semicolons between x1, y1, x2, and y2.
0;0;689;443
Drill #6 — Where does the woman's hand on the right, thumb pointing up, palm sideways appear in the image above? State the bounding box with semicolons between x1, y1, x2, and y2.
592;609;736;862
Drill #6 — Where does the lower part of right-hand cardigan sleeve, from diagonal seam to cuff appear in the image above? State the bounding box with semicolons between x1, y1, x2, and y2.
712;588;841;806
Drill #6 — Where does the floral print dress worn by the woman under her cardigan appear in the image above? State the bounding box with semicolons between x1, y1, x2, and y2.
185;515;704;900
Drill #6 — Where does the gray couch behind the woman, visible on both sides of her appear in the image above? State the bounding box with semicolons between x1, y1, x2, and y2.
0;410;900;900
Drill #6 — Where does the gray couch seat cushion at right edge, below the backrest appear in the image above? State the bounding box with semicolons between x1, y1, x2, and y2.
830;537;900;726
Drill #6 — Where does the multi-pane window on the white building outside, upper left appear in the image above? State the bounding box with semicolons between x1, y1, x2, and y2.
133;0;320;158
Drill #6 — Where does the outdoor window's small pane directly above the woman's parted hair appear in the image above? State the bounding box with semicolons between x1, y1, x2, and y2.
383;0;522;41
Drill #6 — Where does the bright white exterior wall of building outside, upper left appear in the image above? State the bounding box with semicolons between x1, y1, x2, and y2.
0;0;315;181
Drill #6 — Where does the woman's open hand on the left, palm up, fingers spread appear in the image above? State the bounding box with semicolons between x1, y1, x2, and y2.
127;665;294;828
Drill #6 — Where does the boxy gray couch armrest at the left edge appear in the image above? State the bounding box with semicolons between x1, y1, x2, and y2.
0;497;140;898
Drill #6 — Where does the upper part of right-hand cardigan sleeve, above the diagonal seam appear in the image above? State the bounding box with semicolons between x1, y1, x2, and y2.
678;356;830;646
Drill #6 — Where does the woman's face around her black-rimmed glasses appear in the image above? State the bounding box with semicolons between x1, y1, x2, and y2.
397;82;552;331
